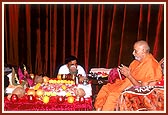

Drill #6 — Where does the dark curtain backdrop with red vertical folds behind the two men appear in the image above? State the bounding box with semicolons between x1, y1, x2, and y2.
3;4;164;77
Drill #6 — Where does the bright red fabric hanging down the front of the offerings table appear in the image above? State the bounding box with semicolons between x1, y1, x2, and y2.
4;96;92;111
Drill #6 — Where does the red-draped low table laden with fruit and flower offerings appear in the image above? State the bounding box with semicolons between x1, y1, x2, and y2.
4;78;92;111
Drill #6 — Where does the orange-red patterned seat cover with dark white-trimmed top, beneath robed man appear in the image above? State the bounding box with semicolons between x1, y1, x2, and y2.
116;86;164;111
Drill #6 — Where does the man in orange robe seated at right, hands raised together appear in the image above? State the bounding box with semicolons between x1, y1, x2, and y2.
94;40;162;111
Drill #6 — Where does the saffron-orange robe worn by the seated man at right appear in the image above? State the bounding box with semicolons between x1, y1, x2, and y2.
94;54;162;111
